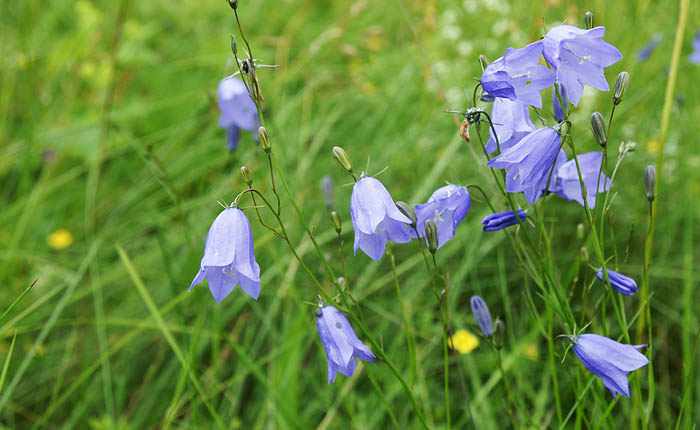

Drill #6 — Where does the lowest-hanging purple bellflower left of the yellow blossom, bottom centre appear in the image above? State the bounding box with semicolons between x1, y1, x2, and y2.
316;306;374;384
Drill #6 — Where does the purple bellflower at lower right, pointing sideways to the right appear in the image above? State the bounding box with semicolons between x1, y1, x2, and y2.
571;334;649;399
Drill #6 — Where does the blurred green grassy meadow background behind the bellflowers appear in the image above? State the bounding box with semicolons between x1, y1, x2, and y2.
0;0;700;430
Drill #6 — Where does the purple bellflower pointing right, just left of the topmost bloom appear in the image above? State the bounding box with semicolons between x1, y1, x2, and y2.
481;42;556;108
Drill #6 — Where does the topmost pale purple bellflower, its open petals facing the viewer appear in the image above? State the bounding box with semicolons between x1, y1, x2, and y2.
542;25;622;106
